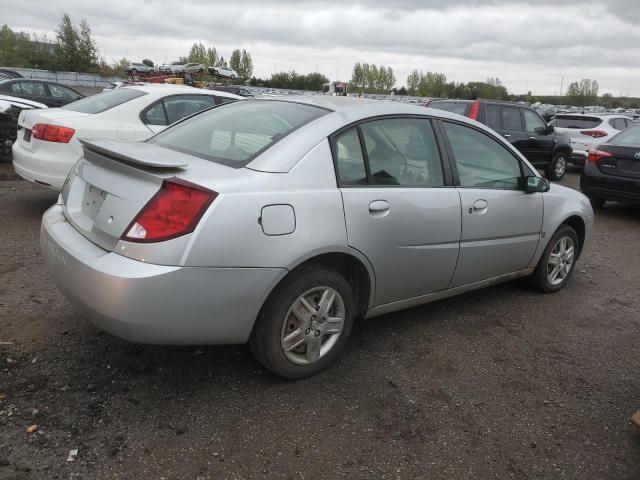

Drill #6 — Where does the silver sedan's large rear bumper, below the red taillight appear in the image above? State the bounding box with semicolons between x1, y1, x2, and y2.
40;205;286;345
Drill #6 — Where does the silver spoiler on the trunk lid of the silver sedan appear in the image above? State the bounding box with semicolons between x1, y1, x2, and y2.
80;139;189;169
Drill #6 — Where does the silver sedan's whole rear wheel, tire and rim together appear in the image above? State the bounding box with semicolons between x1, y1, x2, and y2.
249;265;355;379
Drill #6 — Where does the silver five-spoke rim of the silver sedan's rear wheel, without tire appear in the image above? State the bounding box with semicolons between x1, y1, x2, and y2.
280;287;346;365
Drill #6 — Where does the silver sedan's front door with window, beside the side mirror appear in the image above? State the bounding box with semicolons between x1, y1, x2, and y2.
442;121;543;287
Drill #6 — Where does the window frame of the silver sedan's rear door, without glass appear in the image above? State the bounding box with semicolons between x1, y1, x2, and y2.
328;114;456;188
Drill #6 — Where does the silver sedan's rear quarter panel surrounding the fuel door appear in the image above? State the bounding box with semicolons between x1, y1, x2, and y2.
181;139;347;269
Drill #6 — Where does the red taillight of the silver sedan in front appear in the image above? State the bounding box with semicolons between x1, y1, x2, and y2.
122;178;218;243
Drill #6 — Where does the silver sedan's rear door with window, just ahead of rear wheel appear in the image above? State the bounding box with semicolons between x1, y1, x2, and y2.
332;117;461;306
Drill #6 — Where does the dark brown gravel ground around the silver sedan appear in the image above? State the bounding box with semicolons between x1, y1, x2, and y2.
0;164;640;480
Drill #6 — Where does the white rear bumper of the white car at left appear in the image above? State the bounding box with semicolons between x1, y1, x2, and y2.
13;143;75;192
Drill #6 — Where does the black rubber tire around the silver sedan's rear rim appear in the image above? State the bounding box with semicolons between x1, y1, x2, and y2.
249;265;355;379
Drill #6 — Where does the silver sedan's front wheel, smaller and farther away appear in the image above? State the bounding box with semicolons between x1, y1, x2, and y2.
532;225;579;293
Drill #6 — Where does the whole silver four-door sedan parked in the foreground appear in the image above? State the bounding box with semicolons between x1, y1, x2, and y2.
41;97;593;378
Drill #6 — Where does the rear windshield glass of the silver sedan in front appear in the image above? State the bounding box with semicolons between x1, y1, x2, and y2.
149;100;327;168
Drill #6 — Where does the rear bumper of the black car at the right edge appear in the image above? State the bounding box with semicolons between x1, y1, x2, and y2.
580;162;640;203
